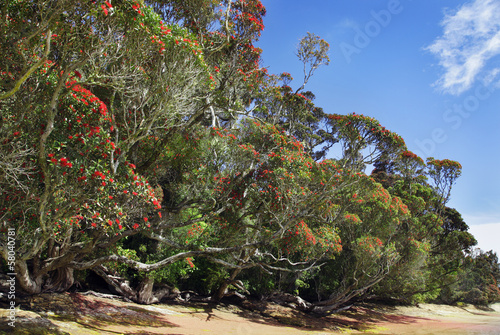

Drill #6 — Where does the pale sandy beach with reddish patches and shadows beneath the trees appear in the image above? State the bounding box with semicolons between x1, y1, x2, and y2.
0;293;500;335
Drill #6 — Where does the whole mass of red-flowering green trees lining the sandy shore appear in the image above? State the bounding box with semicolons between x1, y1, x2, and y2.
0;0;500;313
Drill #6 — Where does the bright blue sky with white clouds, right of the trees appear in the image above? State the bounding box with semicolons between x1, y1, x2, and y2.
257;0;500;255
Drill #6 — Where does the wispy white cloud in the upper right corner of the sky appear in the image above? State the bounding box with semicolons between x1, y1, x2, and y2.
426;0;500;95
